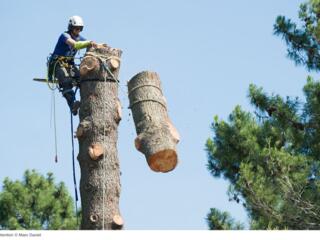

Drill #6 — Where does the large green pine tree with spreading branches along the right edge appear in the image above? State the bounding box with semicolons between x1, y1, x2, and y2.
206;0;320;229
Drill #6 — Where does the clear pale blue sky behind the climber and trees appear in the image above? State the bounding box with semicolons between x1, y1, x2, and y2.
0;0;308;230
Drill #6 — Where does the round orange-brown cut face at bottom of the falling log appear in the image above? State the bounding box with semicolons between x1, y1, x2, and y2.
147;149;178;173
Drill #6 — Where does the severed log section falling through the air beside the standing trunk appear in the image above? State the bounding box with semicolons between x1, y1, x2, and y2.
128;71;179;172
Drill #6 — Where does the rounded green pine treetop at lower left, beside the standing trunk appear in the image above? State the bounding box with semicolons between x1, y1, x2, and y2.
0;170;78;230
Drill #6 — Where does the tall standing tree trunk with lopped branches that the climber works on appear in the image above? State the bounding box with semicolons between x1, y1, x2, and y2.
76;46;123;229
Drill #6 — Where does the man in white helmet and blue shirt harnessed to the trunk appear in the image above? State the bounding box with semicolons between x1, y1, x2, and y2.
48;16;97;115
